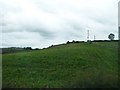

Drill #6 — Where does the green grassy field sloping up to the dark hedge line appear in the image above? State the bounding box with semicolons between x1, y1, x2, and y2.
2;42;118;88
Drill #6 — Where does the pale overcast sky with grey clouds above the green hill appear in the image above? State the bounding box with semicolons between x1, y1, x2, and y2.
0;0;119;48
